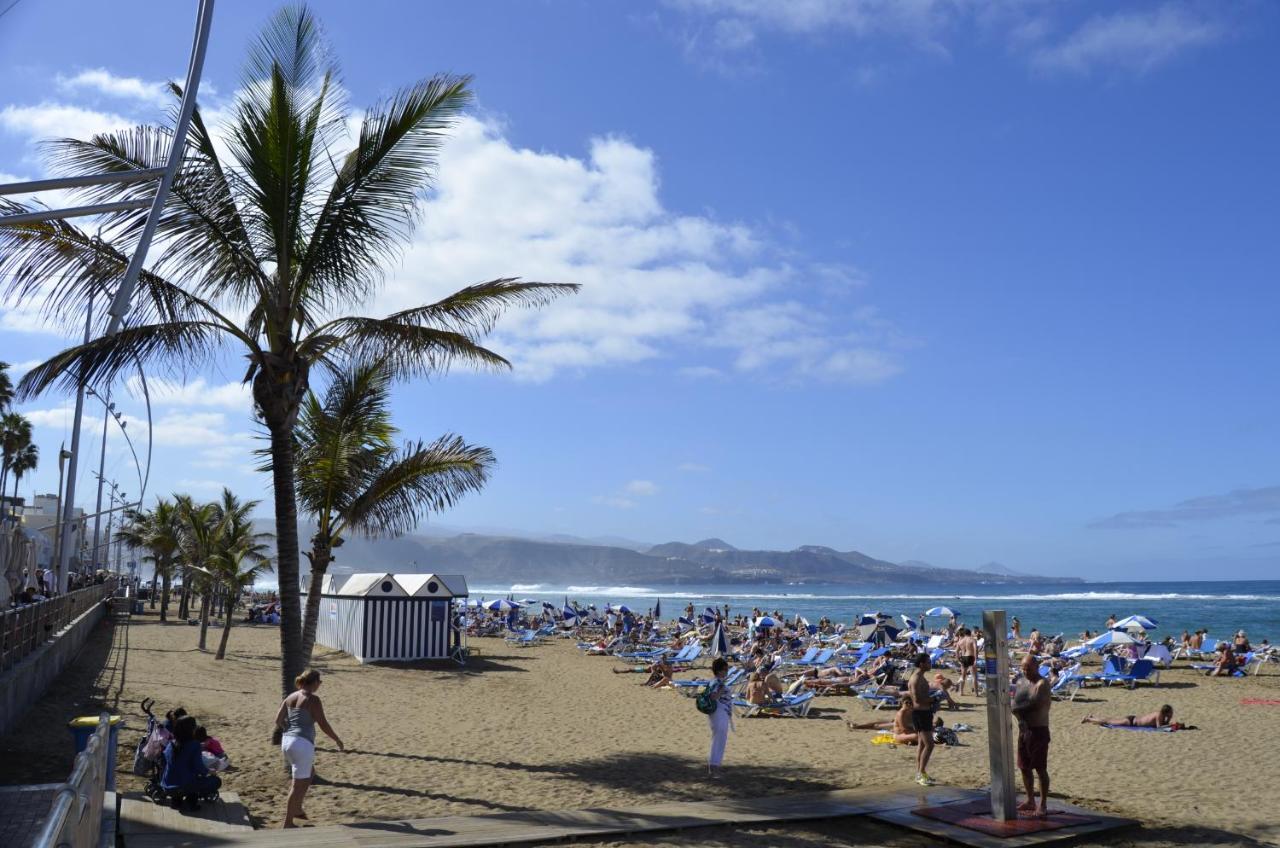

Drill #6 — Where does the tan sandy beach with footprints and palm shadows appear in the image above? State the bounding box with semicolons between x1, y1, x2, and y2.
0;615;1280;848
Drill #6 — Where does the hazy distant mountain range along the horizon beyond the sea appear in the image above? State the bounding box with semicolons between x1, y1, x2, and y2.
302;526;1080;585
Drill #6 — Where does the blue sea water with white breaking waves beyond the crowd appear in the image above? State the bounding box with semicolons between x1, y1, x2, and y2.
471;580;1280;643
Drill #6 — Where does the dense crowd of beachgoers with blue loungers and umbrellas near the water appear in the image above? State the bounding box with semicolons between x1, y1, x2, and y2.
463;599;1280;717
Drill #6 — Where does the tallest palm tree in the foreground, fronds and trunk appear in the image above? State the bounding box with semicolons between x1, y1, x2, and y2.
0;6;576;692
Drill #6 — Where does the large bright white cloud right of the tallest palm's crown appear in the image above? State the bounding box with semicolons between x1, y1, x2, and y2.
378;118;890;379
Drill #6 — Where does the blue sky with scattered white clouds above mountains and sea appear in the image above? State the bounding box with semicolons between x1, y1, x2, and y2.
0;0;1280;579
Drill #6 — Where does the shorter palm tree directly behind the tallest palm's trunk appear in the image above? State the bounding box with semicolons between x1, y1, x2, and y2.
294;364;494;662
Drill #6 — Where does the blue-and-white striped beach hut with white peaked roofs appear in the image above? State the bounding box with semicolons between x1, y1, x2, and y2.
309;571;467;662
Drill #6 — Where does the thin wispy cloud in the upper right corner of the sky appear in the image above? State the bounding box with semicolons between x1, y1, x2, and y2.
1032;3;1226;74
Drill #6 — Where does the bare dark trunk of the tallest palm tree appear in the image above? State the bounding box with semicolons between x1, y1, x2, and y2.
264;417;307;696
